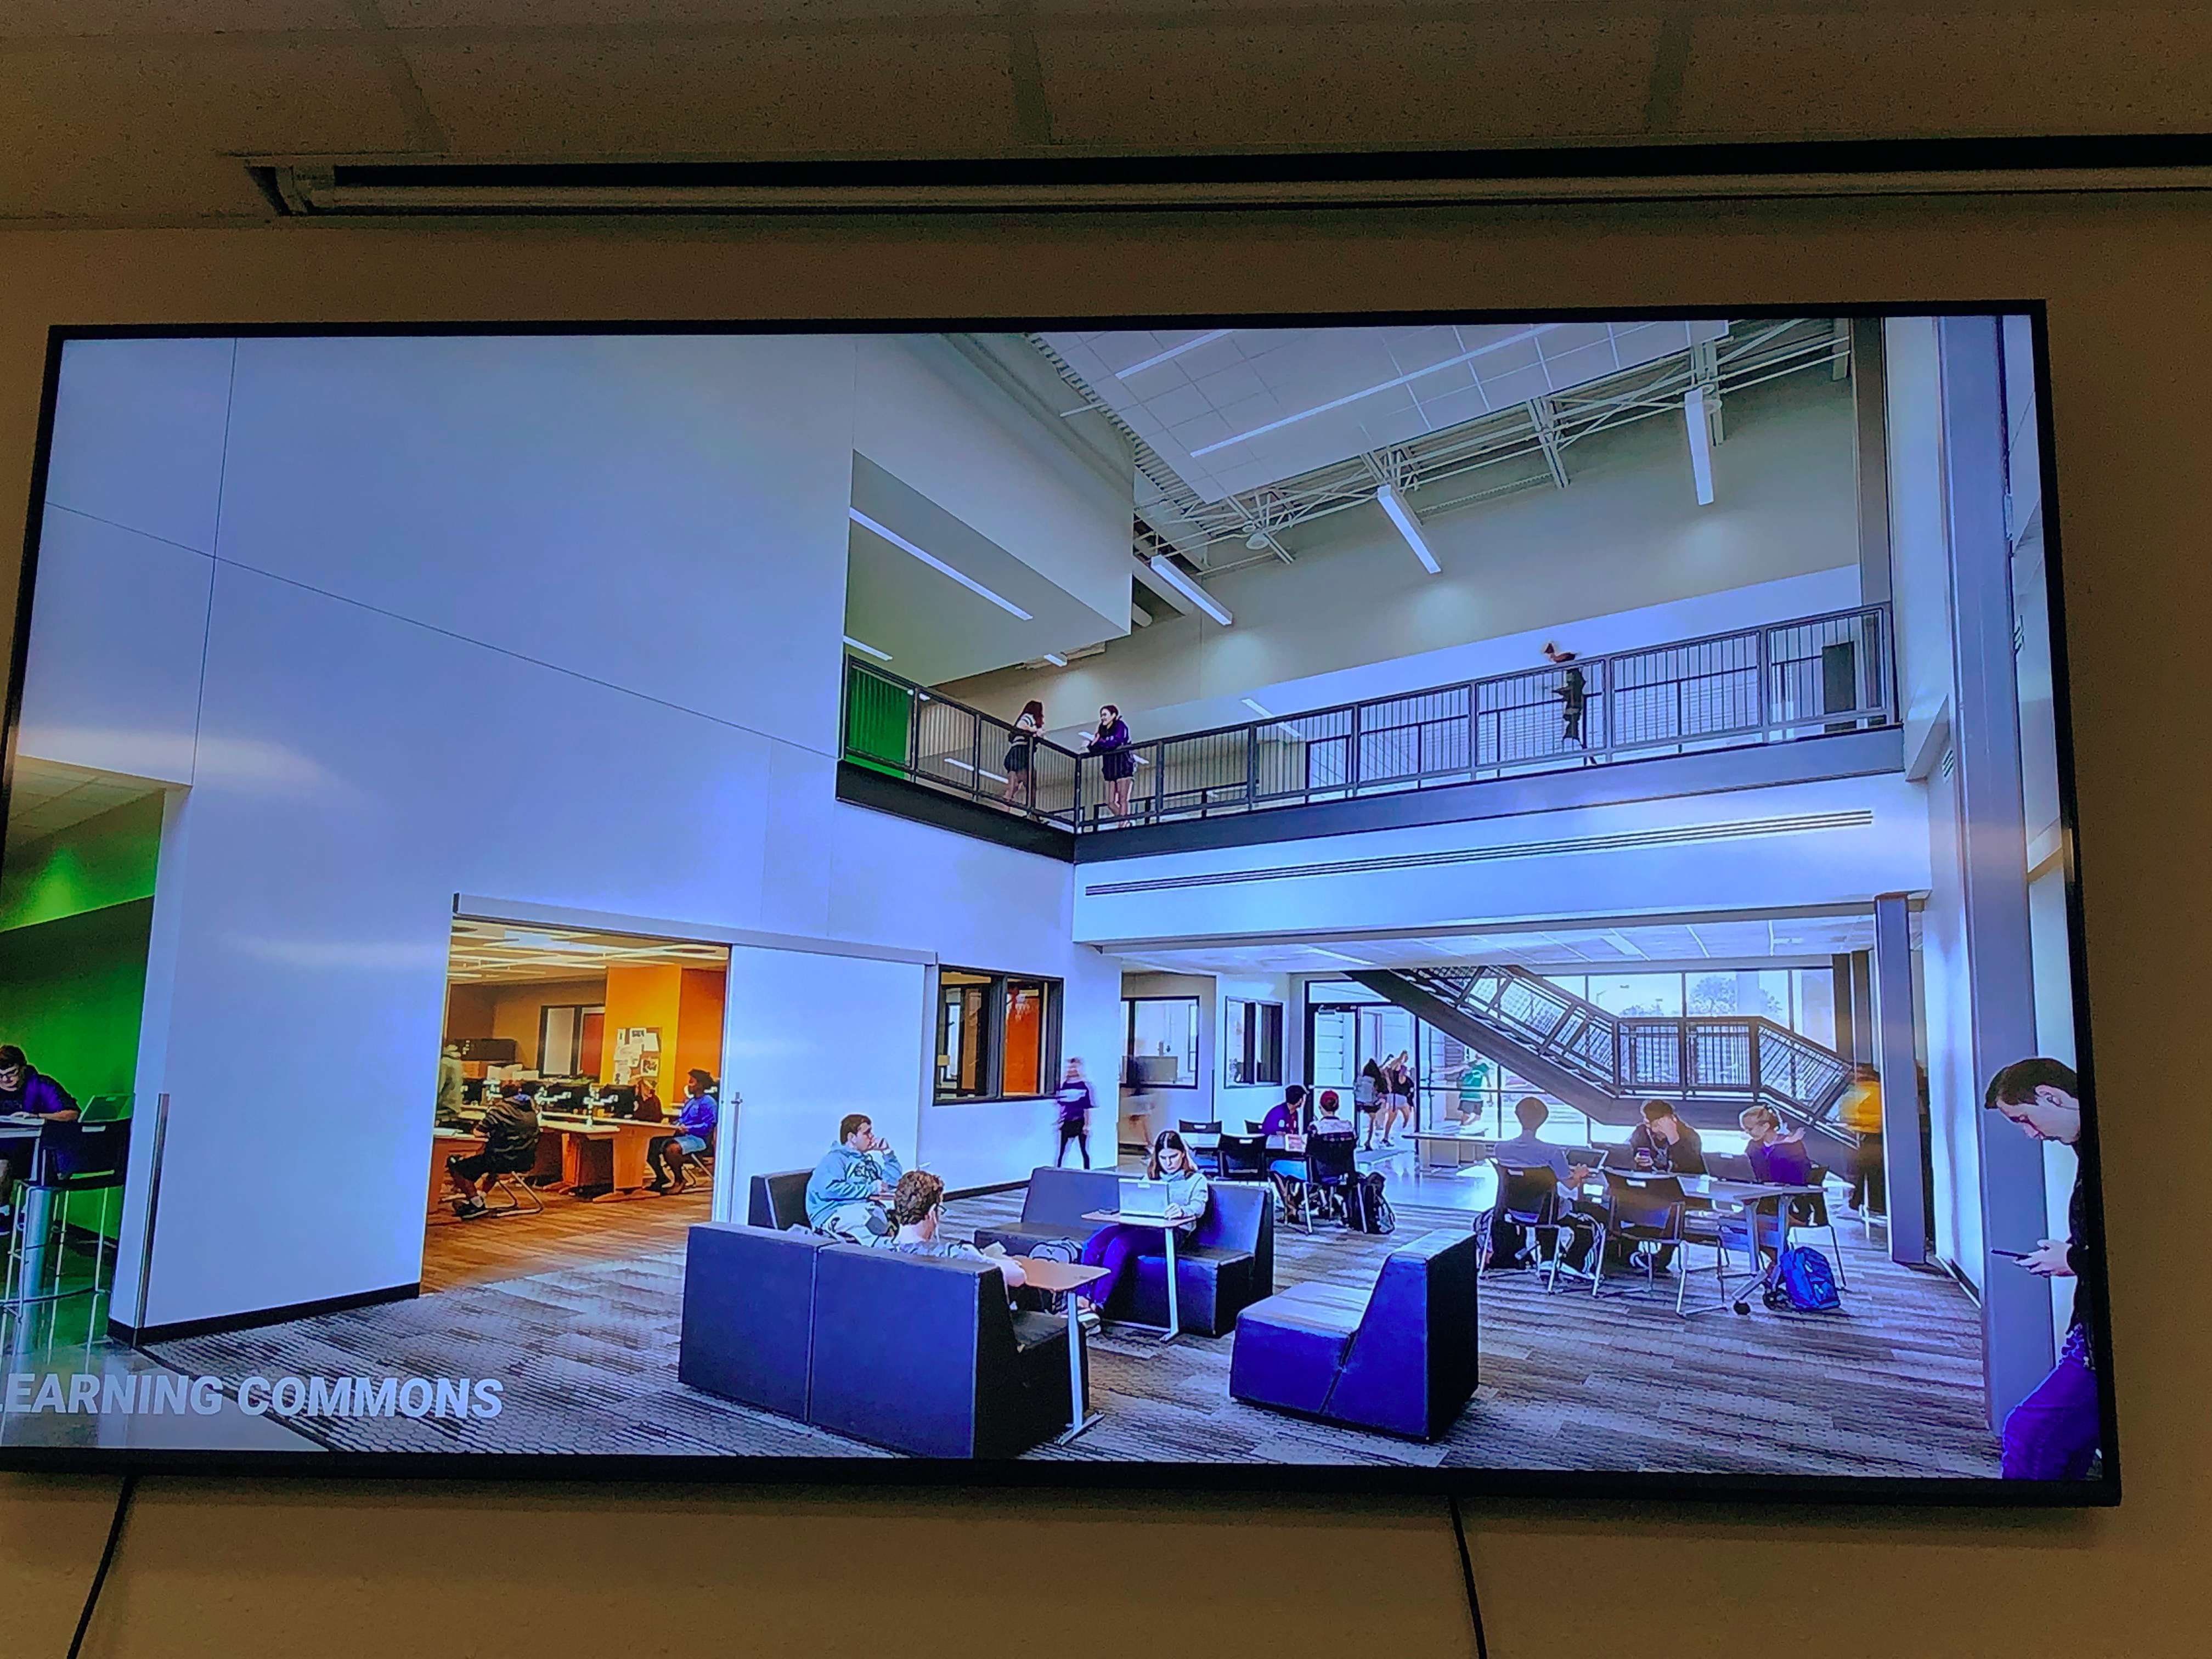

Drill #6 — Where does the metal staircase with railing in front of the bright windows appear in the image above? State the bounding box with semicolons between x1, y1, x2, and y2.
1352;964;1856;1150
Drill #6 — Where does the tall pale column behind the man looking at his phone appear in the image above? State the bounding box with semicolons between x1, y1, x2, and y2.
1938;317;2053;1427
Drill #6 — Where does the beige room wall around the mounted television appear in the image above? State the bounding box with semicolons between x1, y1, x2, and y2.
0;199;2212;1659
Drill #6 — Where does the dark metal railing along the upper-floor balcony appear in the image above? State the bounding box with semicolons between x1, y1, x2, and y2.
845;606;1898;832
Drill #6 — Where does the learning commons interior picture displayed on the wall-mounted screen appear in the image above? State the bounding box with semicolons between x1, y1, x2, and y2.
0;314;2117;1502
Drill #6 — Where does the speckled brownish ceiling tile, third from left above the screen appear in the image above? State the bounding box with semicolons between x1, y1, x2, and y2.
1037;13;1659;146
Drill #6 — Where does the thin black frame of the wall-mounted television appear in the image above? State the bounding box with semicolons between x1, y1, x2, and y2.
0;298;2121;1509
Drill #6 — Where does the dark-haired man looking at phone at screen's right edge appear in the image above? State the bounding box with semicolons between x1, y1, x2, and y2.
1982;1057;2103;1480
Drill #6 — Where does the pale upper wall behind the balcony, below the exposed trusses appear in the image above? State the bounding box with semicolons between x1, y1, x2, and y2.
947;374;1858;737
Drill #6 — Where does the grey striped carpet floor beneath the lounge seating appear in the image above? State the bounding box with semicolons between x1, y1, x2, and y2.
147;1192;1997;1475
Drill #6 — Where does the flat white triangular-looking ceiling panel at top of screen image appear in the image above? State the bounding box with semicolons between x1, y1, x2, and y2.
1042;319;1728;502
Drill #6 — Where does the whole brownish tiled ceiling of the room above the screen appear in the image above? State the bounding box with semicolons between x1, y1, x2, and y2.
0;0;2212;225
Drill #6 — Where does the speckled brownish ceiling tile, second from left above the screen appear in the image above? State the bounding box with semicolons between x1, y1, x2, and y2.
398;33;1015;155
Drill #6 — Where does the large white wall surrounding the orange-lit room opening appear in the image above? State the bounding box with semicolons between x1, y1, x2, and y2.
24;336;1115;1325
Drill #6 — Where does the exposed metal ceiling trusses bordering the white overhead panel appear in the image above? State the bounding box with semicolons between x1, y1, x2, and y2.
1029;317;1852;573
